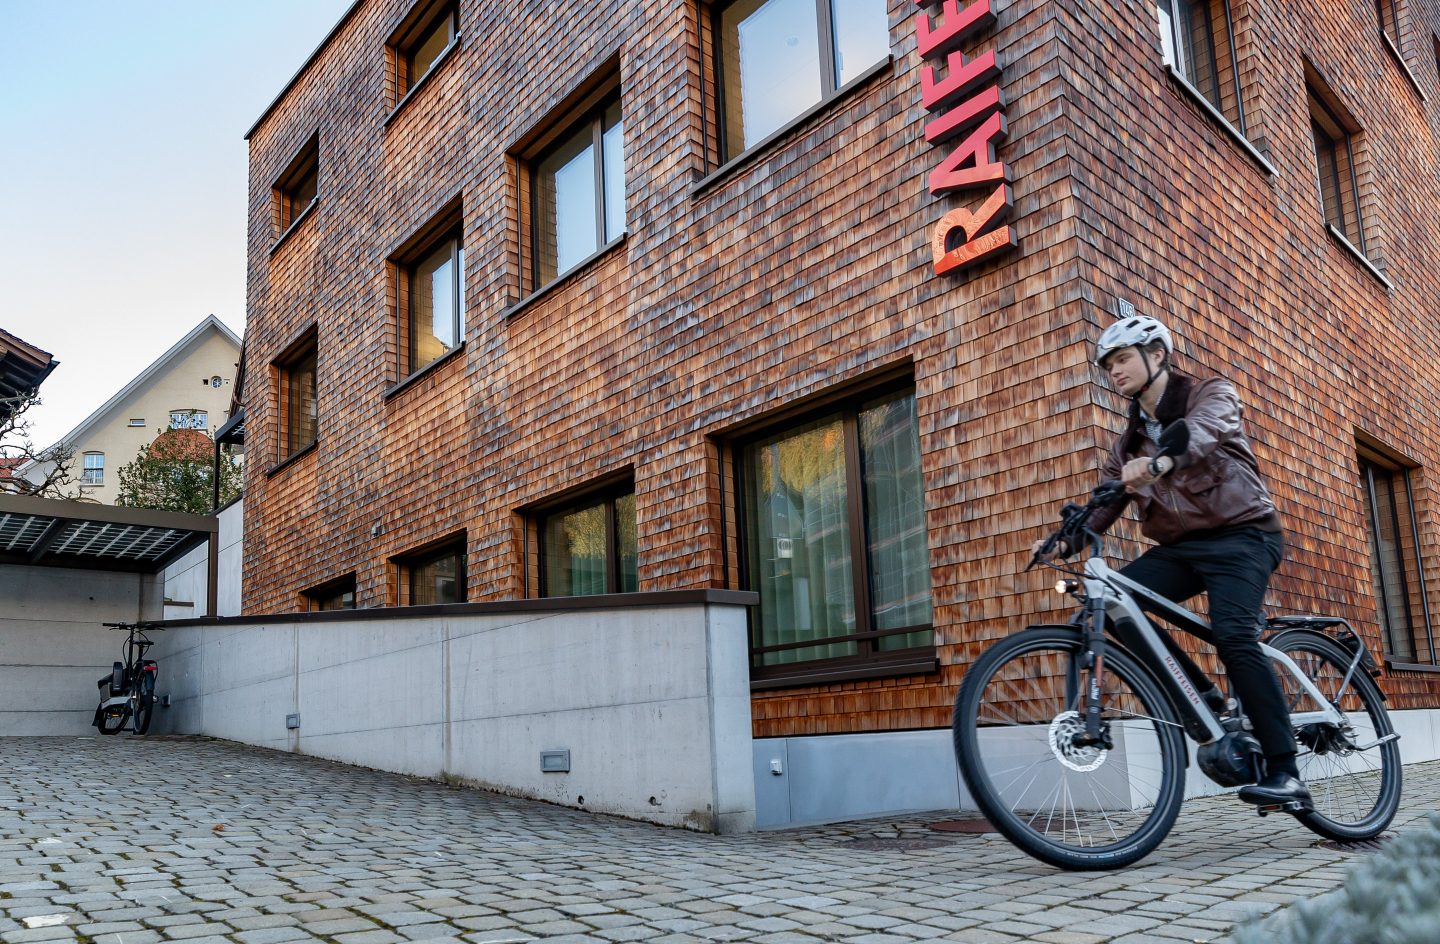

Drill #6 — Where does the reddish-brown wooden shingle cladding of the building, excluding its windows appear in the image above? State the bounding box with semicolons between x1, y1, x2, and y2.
245;0;1440;735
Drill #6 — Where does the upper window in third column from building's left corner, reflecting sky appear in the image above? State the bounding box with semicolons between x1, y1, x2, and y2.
530;98;625;286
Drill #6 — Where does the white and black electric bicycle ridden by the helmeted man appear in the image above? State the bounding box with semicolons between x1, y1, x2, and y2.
953;422;1401;869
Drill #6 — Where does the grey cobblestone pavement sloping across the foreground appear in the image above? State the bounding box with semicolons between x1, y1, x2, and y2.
0;737;1440;944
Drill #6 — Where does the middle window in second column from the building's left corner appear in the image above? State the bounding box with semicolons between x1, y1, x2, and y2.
395;222;465;376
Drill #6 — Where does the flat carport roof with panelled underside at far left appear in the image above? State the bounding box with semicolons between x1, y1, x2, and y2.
0;495;216;573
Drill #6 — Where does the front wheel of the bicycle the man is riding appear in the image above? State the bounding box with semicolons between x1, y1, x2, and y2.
952;626;1187;871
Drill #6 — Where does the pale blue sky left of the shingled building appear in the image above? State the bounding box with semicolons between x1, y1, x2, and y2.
0;0;351;443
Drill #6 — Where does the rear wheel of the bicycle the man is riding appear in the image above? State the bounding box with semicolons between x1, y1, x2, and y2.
1270;630;1403;842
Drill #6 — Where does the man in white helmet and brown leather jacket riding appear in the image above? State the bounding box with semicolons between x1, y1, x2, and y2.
1034;317;1310;809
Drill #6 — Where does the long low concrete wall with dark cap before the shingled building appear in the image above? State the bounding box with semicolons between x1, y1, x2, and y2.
154;591;755;832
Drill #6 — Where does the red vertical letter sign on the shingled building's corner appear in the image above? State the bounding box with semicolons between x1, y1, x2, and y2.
914;0;1020;275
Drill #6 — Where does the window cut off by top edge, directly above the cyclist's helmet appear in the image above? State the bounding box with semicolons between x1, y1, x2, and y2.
1158;0;1246;134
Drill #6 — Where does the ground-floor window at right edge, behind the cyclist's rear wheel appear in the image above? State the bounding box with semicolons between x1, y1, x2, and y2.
1359;446;1436;665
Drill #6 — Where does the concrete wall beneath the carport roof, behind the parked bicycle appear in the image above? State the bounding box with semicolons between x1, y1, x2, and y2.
0;564;160;735
